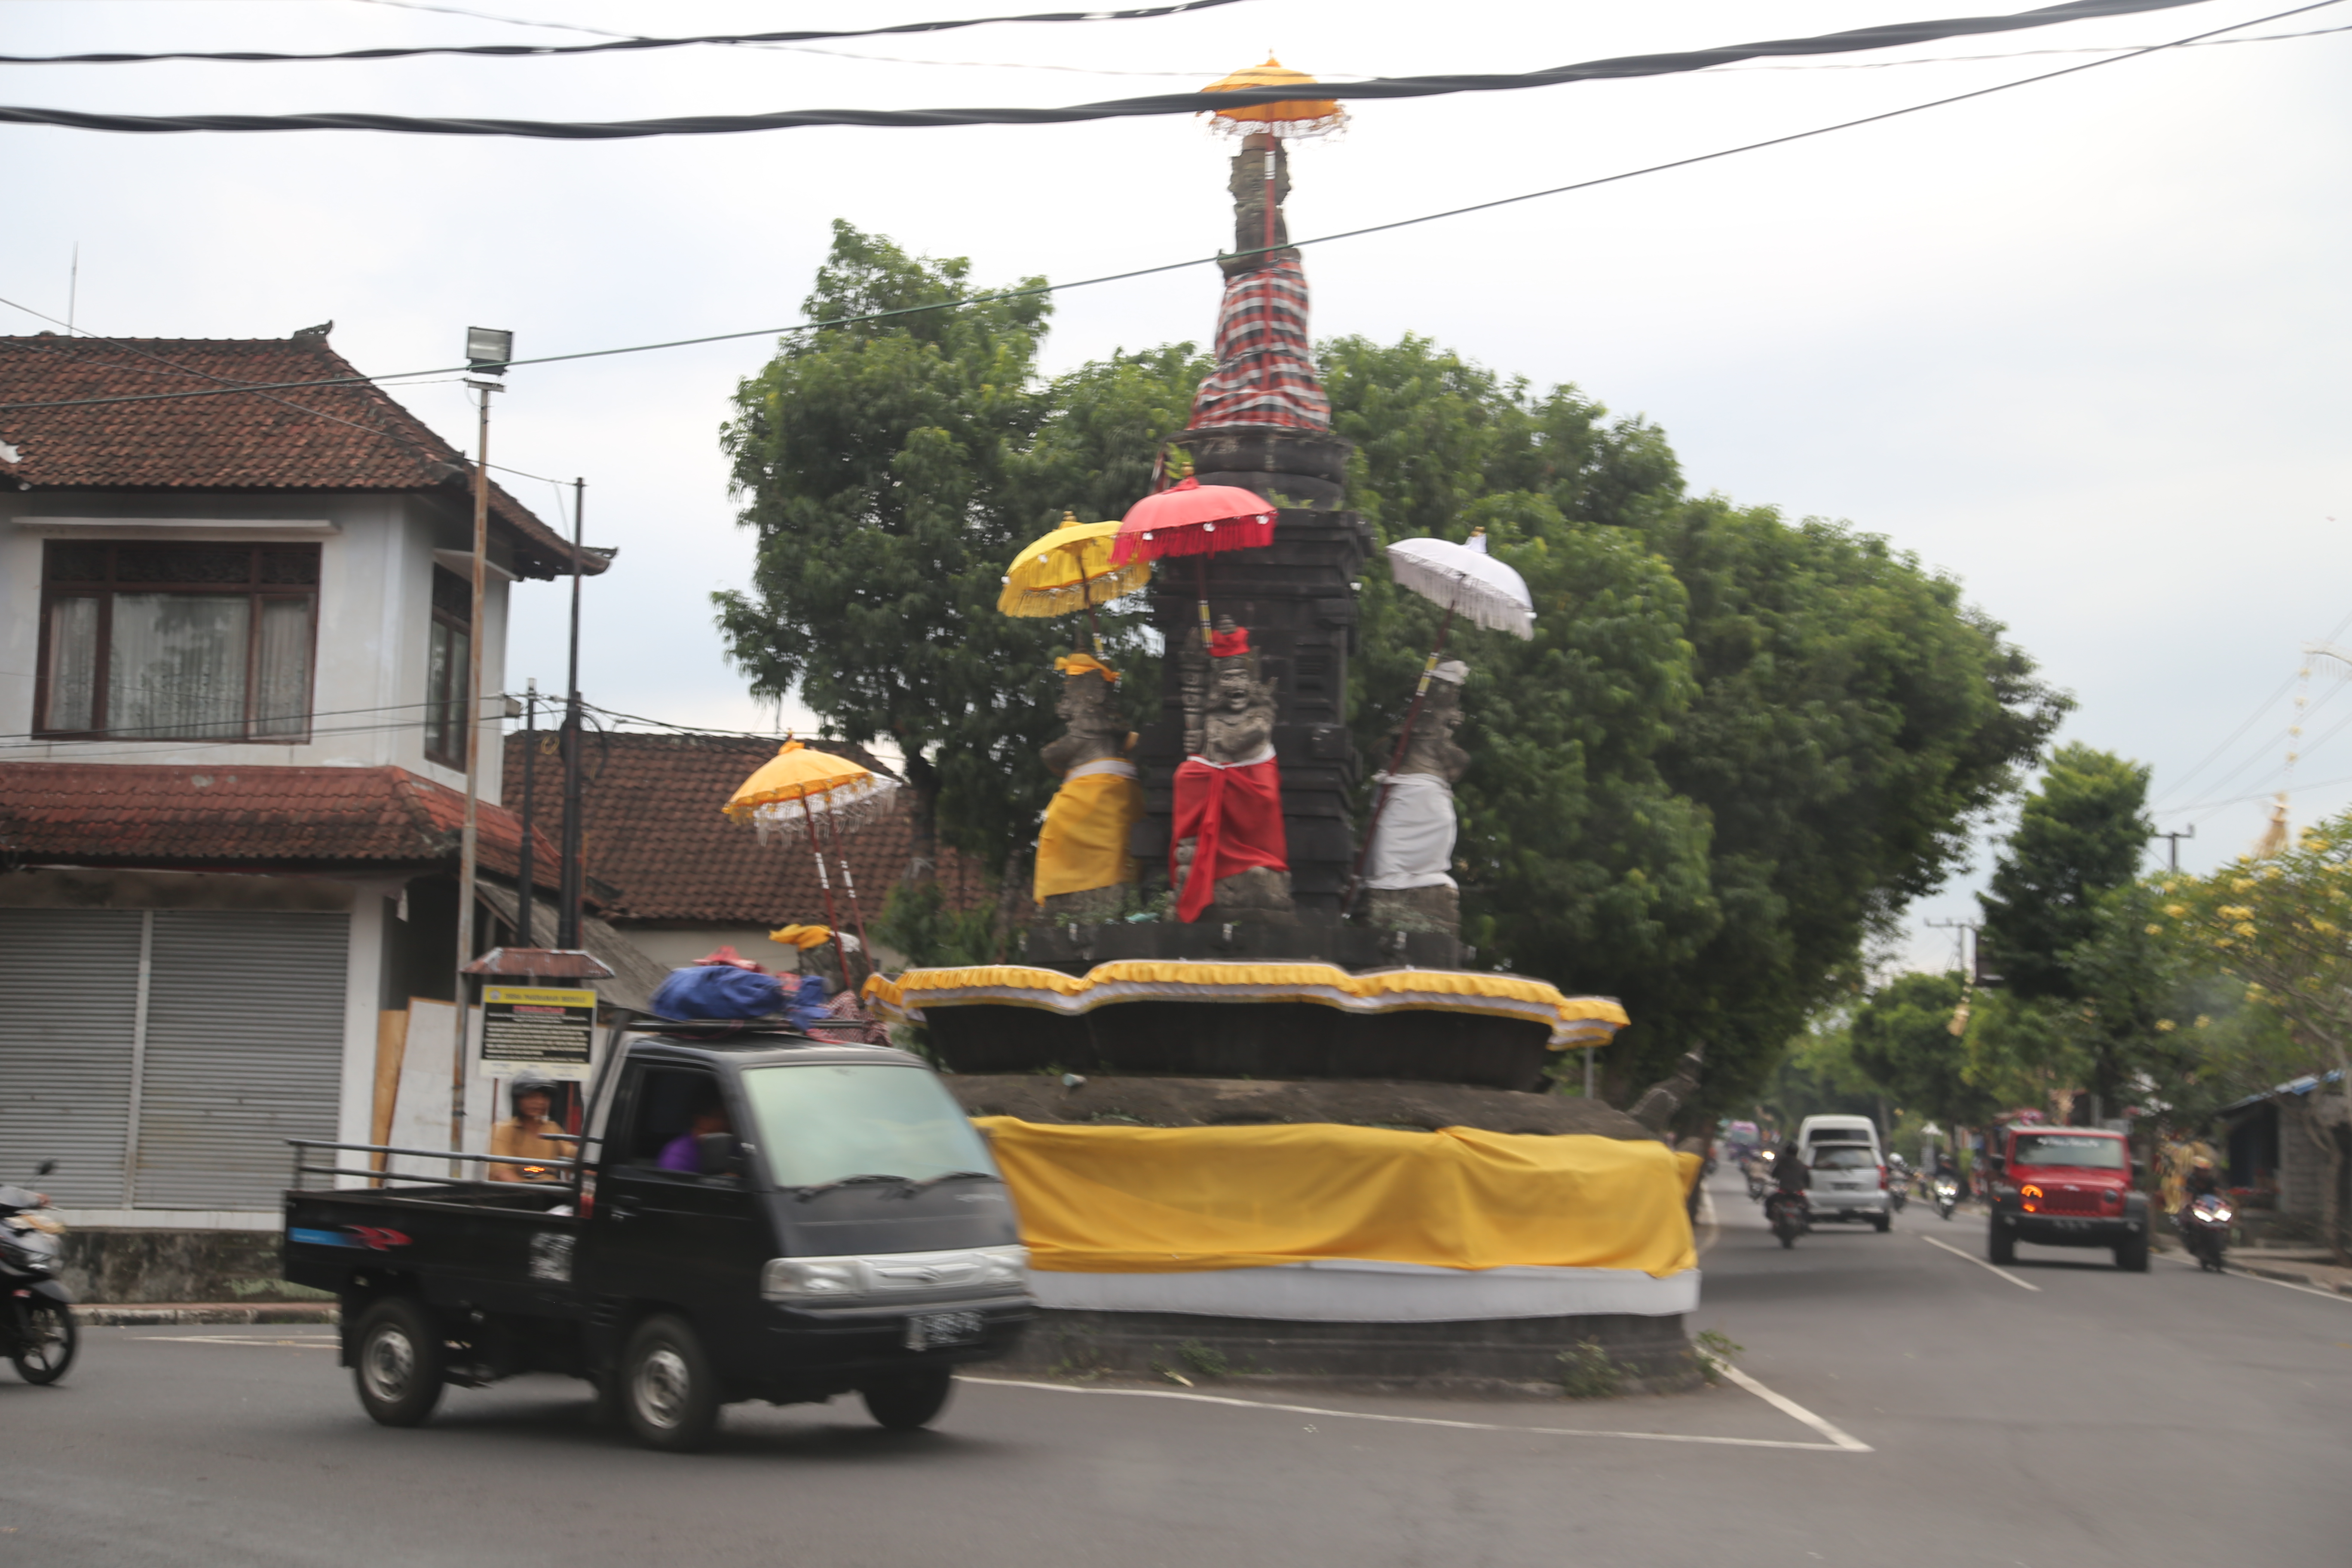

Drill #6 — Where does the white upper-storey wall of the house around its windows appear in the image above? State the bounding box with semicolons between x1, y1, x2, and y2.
0;491;508;802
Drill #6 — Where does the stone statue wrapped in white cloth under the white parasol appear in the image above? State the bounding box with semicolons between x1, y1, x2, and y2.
1364;658;1470;936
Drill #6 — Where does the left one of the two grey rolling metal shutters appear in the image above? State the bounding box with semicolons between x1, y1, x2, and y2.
0;910;141;1208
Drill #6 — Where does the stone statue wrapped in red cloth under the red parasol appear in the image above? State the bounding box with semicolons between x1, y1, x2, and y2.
1169;616;1294;924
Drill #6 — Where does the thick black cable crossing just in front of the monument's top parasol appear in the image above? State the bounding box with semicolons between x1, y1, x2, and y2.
0;0;2248;141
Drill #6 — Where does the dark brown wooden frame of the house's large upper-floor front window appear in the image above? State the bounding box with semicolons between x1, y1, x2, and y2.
33;538;322;745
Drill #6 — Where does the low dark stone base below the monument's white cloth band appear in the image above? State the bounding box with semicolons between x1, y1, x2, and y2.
1002;1307;1700;1399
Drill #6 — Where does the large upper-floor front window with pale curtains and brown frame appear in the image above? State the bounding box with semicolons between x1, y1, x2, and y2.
38;538;318;741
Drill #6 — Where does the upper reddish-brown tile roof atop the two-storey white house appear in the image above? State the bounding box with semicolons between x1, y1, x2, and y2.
0;334;609;578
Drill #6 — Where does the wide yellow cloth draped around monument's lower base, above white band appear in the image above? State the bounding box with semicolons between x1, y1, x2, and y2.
978;1117;1698;1279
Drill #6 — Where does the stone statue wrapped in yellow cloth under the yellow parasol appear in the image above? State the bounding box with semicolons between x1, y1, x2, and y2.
1032;653;1143;924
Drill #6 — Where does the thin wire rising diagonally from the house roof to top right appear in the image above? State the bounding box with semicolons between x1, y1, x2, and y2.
0;0;2340;414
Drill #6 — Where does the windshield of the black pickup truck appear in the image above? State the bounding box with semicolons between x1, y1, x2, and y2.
743;1063;995;1187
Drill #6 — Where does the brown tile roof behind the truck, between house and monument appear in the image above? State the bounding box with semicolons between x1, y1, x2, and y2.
503;733;988;926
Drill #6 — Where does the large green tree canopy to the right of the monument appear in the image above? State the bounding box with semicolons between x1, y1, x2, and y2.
1322;339;2067;1109
